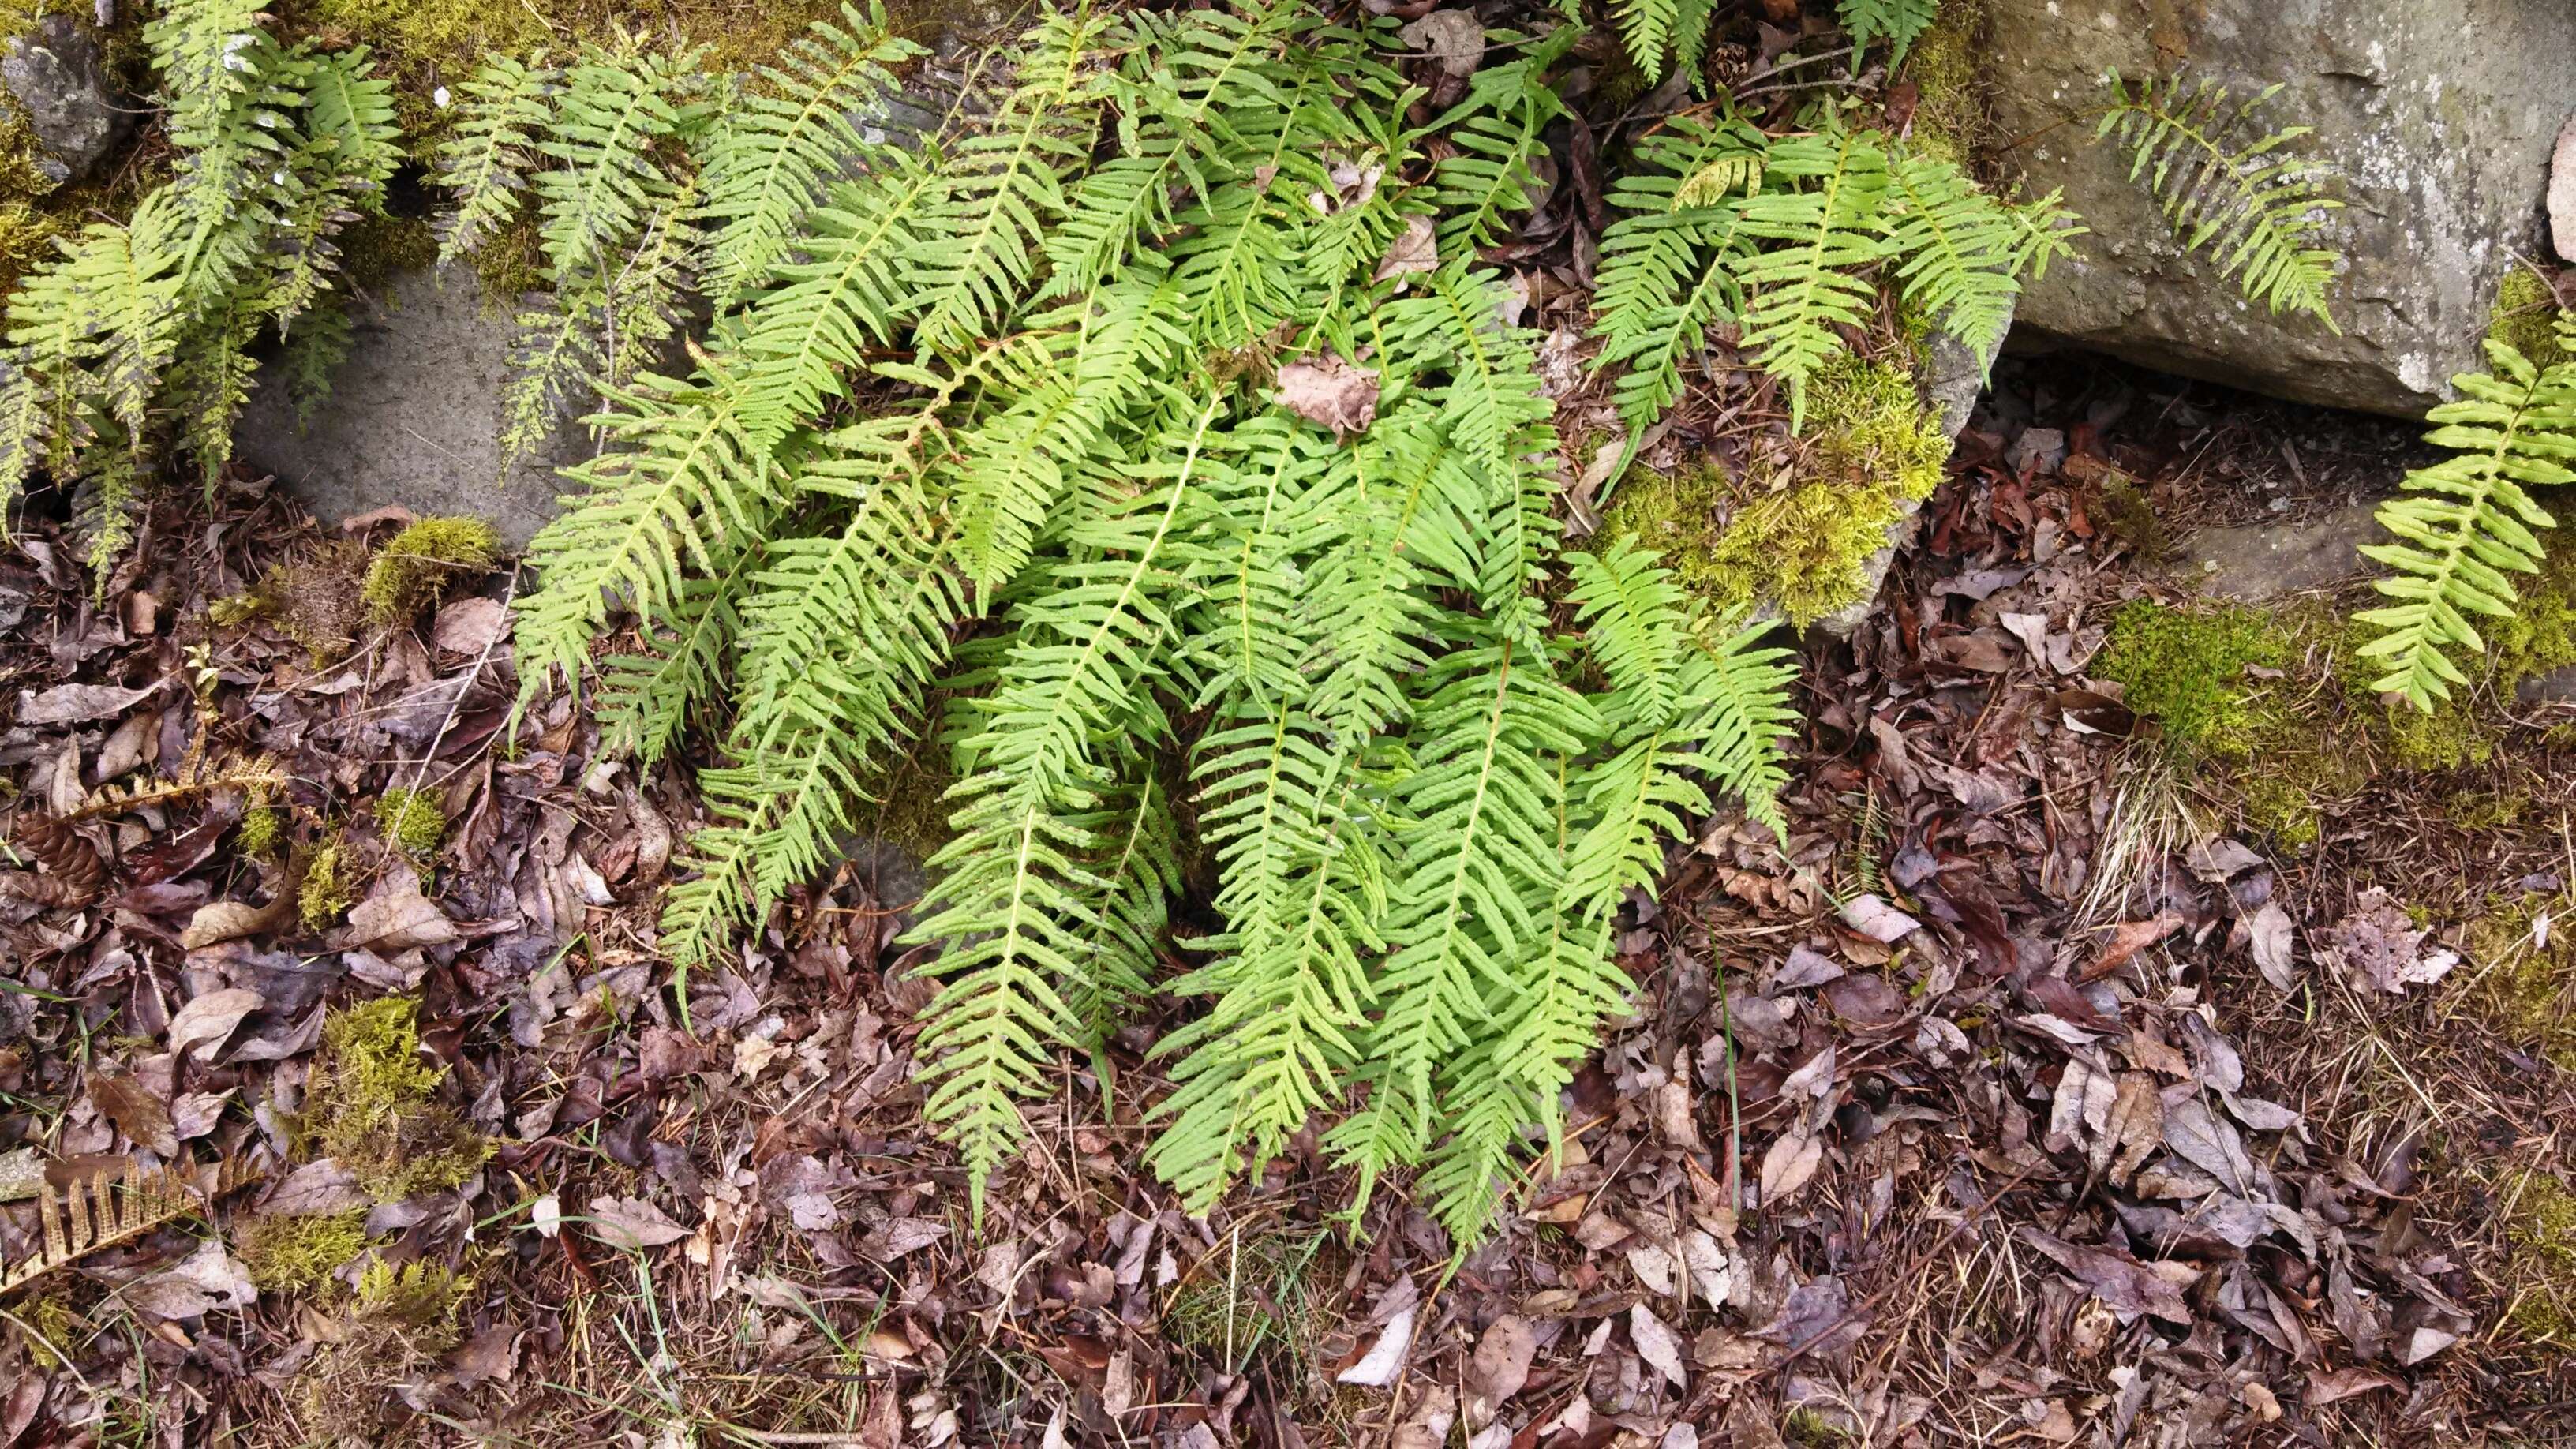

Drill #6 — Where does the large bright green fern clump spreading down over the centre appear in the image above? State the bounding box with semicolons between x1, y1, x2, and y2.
484;0;1788;1245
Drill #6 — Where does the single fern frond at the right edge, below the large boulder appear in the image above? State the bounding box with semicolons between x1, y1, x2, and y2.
2357;322;2576;712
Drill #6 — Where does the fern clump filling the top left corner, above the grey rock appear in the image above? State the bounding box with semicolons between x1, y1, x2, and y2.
0;0;399;570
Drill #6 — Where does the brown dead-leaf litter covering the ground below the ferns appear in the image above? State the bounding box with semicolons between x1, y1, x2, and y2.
15;340;2576;1449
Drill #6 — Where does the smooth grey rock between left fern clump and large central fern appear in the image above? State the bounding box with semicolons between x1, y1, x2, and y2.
237;271;587;549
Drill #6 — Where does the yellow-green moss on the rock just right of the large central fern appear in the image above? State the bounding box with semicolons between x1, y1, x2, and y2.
1600;358;1950;627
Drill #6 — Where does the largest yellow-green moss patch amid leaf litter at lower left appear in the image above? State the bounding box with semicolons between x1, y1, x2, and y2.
299;995;492;1201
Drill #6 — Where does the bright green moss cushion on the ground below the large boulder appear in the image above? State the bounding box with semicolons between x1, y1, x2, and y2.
2095;598;2290;761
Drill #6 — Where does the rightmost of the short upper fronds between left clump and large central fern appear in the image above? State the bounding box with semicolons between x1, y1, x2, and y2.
701;0;923;307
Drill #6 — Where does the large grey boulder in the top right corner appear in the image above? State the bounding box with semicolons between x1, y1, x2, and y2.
1986;0;2576;415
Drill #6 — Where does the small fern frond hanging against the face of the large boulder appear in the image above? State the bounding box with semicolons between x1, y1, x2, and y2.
2095;72;2342;332
